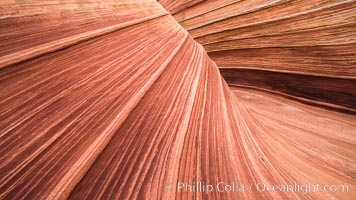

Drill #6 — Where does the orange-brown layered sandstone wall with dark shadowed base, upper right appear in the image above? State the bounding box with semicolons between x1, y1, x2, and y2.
159;0;356;113
